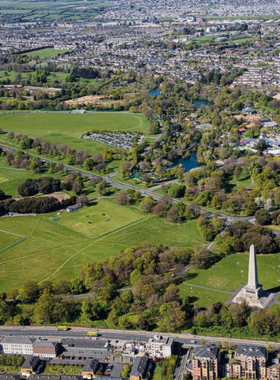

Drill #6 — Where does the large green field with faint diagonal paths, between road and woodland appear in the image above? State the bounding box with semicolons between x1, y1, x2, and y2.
0;199;205;291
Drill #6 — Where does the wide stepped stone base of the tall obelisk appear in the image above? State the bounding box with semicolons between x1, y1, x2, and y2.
228;285;274;309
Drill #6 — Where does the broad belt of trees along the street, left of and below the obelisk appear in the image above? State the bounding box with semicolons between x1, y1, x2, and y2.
0;243;280;338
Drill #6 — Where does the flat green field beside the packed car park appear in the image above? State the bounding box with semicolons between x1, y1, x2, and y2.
0;112;148;152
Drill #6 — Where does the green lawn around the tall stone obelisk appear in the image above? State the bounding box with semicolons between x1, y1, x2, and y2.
180;253;280;306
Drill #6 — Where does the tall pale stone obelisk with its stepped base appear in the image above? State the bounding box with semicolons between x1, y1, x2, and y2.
228;245;273;308
